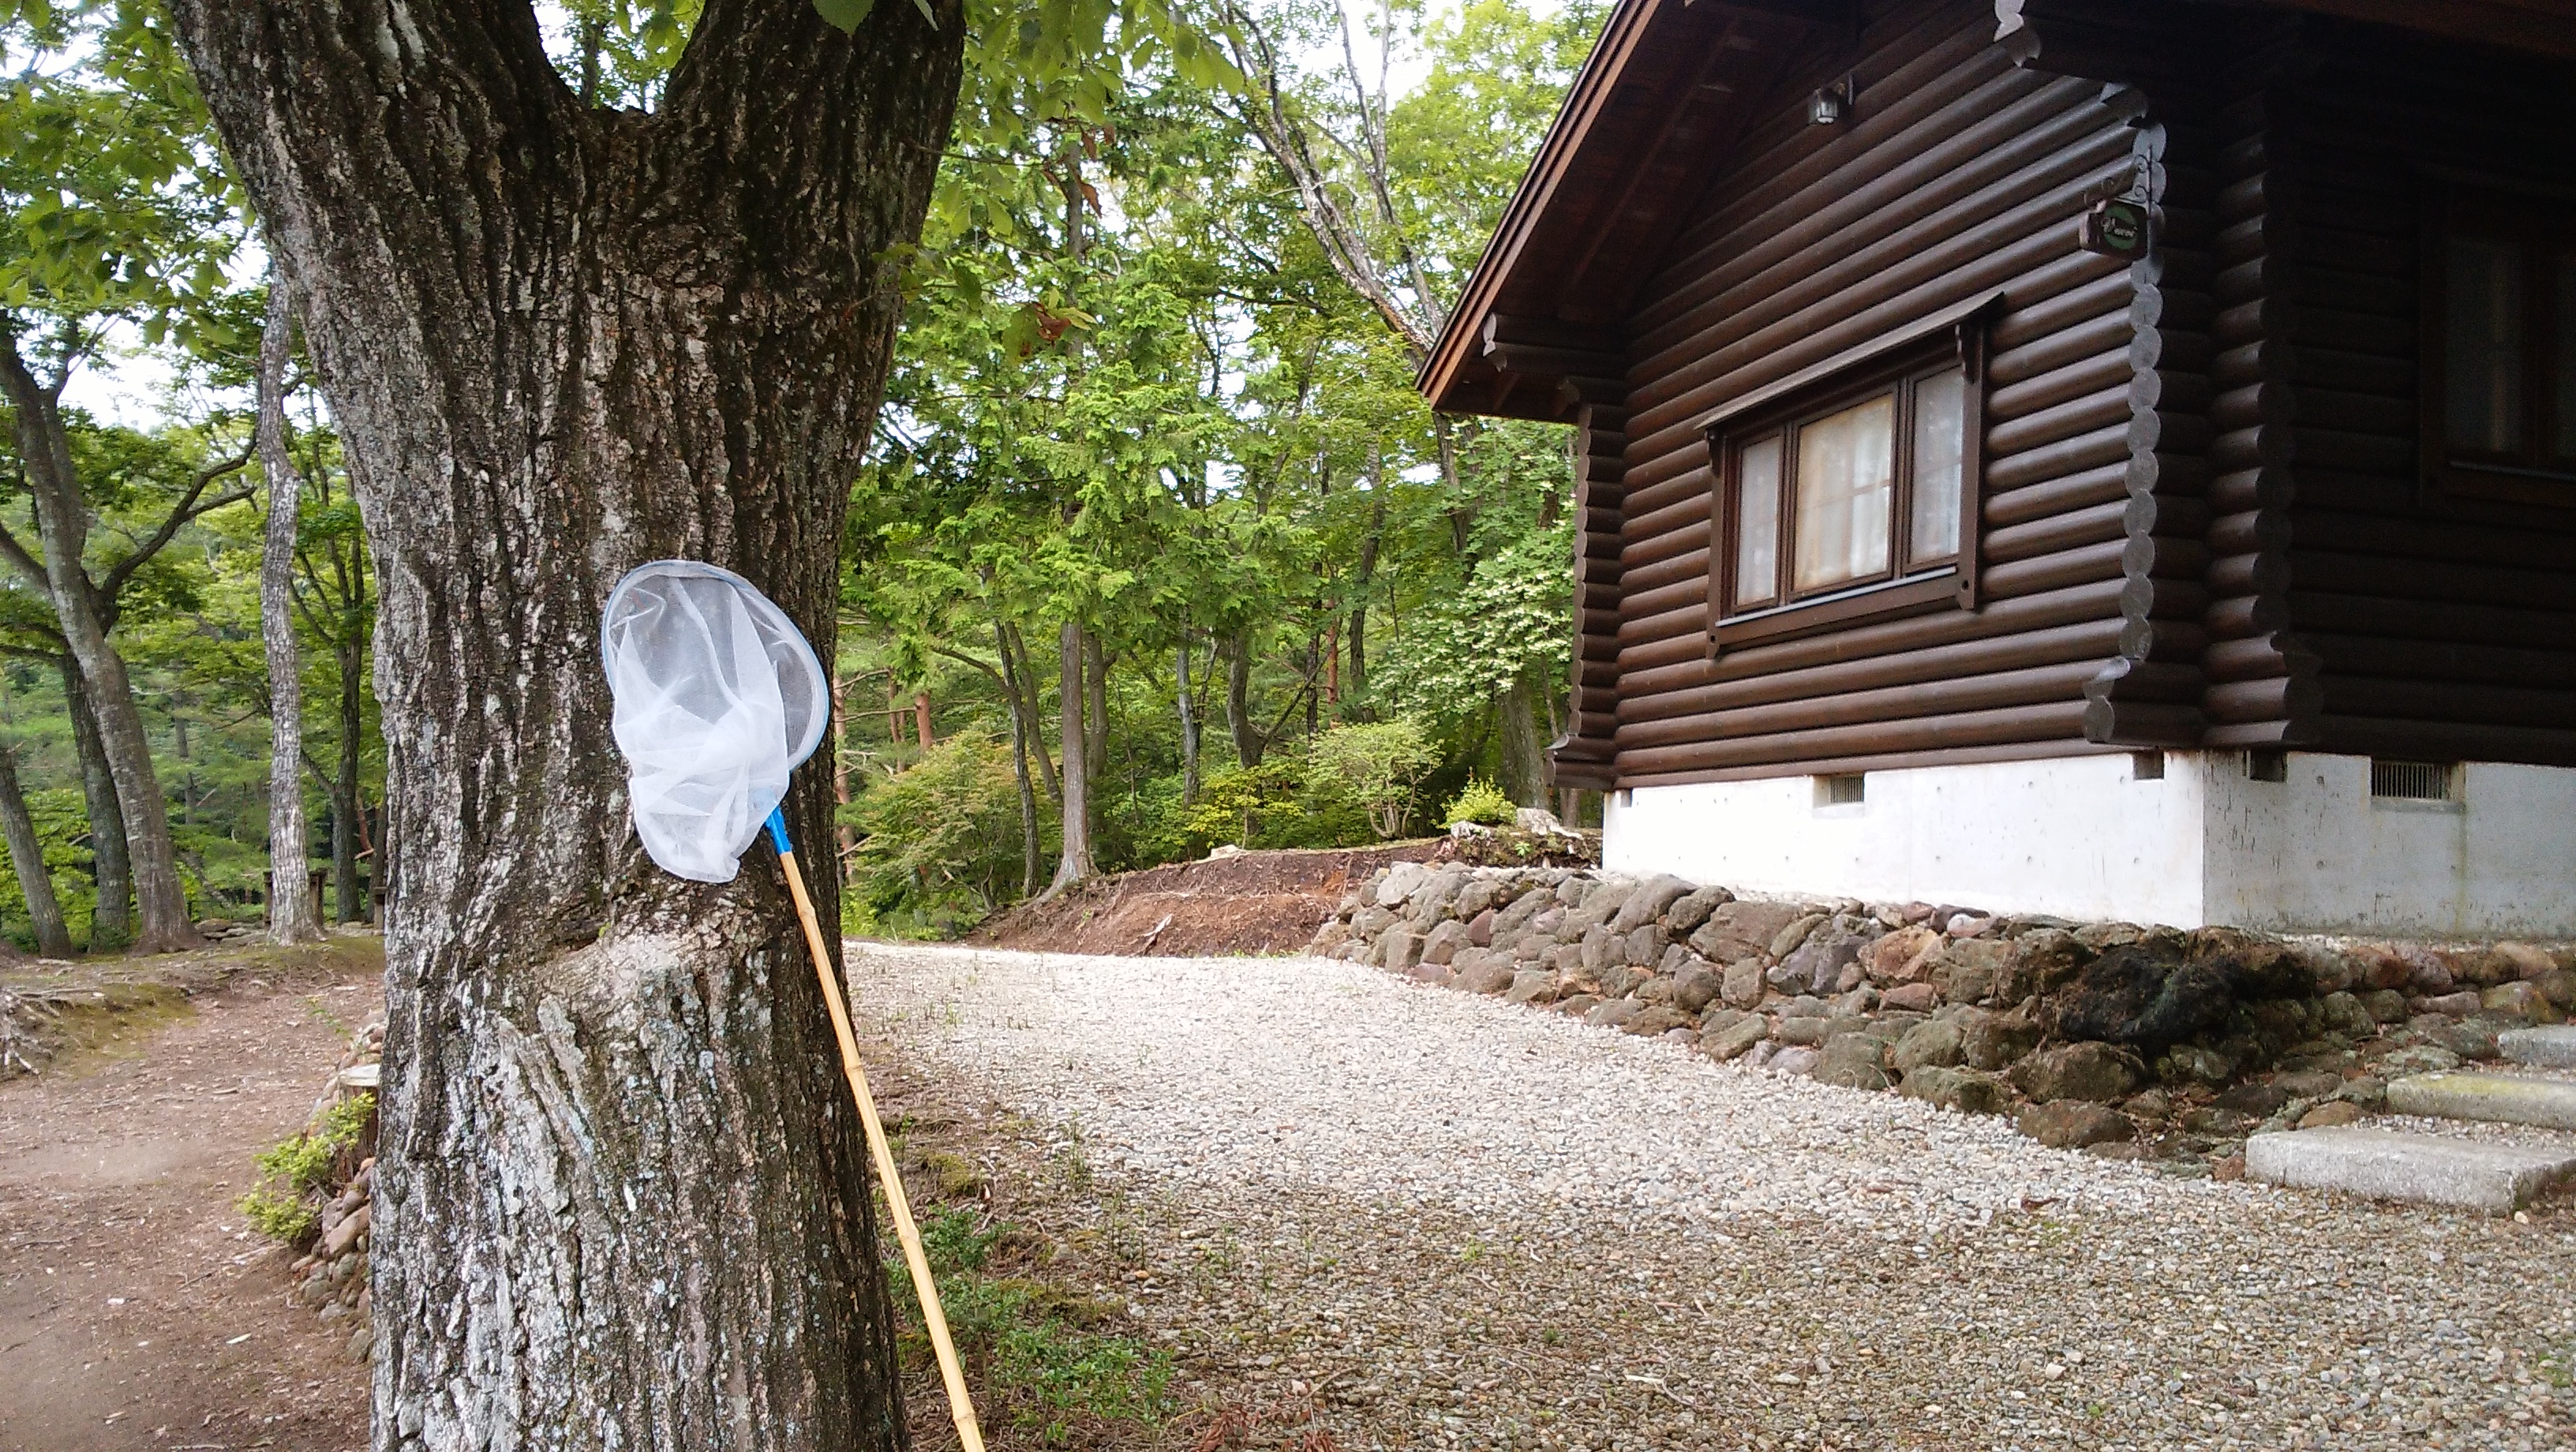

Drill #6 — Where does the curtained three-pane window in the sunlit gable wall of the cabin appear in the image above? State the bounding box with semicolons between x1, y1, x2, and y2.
1710;327;1979;646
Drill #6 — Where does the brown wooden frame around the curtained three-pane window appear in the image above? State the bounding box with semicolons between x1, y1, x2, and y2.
1703;306;2001;657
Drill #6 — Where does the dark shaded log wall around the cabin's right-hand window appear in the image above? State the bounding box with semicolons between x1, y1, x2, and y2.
2275;21;2576;765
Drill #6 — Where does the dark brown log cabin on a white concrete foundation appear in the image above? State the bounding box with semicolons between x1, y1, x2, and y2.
1419;0;2576;937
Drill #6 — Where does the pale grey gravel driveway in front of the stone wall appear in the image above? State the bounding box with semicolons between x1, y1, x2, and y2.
850;945;2576;1452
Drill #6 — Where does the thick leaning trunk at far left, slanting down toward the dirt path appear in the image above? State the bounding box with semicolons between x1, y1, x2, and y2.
0;340;198;952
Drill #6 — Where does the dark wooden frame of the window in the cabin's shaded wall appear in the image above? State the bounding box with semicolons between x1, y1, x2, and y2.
2417;185;2576;510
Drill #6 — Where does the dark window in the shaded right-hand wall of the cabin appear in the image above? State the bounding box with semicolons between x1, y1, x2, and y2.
2424;193;2576;507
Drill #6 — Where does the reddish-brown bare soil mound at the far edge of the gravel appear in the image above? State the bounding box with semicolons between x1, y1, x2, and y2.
974;836;1455;958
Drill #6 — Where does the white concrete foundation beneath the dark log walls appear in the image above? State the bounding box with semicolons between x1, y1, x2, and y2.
1602;752;2576;937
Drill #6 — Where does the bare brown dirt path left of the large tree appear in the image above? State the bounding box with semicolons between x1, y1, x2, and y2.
0;955;381;1452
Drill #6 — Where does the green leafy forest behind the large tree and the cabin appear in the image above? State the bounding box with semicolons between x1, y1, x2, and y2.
0;0;1600;950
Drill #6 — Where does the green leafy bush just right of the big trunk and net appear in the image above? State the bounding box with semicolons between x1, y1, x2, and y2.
848;726;1020;937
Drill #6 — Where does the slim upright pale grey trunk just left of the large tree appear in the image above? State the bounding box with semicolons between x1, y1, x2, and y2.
257;278;324;942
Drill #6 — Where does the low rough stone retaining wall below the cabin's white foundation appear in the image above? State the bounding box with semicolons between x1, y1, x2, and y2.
1309;863;2576;1174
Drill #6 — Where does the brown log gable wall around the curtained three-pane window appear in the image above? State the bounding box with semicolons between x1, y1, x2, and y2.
1584;0;2174;785
